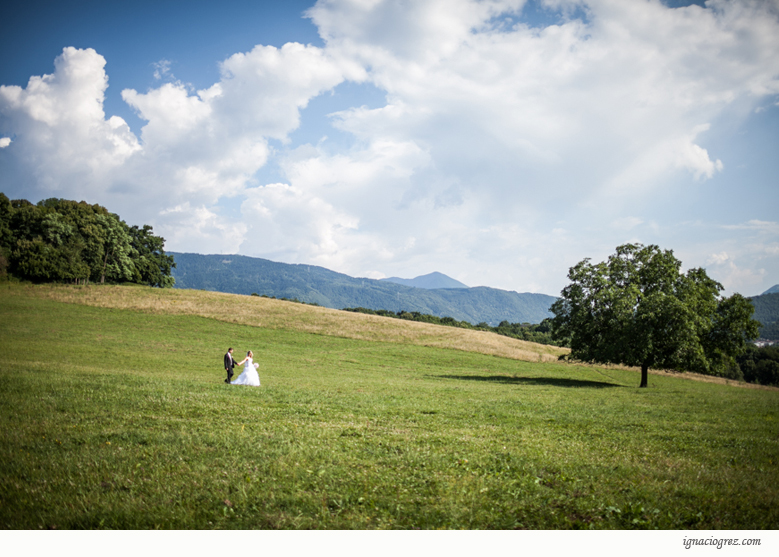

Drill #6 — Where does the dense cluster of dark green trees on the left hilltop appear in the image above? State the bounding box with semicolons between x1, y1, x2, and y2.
0;193;175;287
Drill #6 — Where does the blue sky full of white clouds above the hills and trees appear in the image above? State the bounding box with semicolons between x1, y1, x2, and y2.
0;0;779;296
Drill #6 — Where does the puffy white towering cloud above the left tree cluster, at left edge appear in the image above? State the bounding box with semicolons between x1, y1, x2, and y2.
0;47;140;195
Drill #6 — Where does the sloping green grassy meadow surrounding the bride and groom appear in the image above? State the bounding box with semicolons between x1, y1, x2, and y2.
0;284;779;529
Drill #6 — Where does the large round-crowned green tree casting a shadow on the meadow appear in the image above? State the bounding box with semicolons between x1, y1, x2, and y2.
551;244;759;387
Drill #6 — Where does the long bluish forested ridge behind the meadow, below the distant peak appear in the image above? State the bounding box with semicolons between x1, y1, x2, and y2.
169;252;556;326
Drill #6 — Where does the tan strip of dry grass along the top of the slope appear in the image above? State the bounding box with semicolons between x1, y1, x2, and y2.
22;285;569;362
